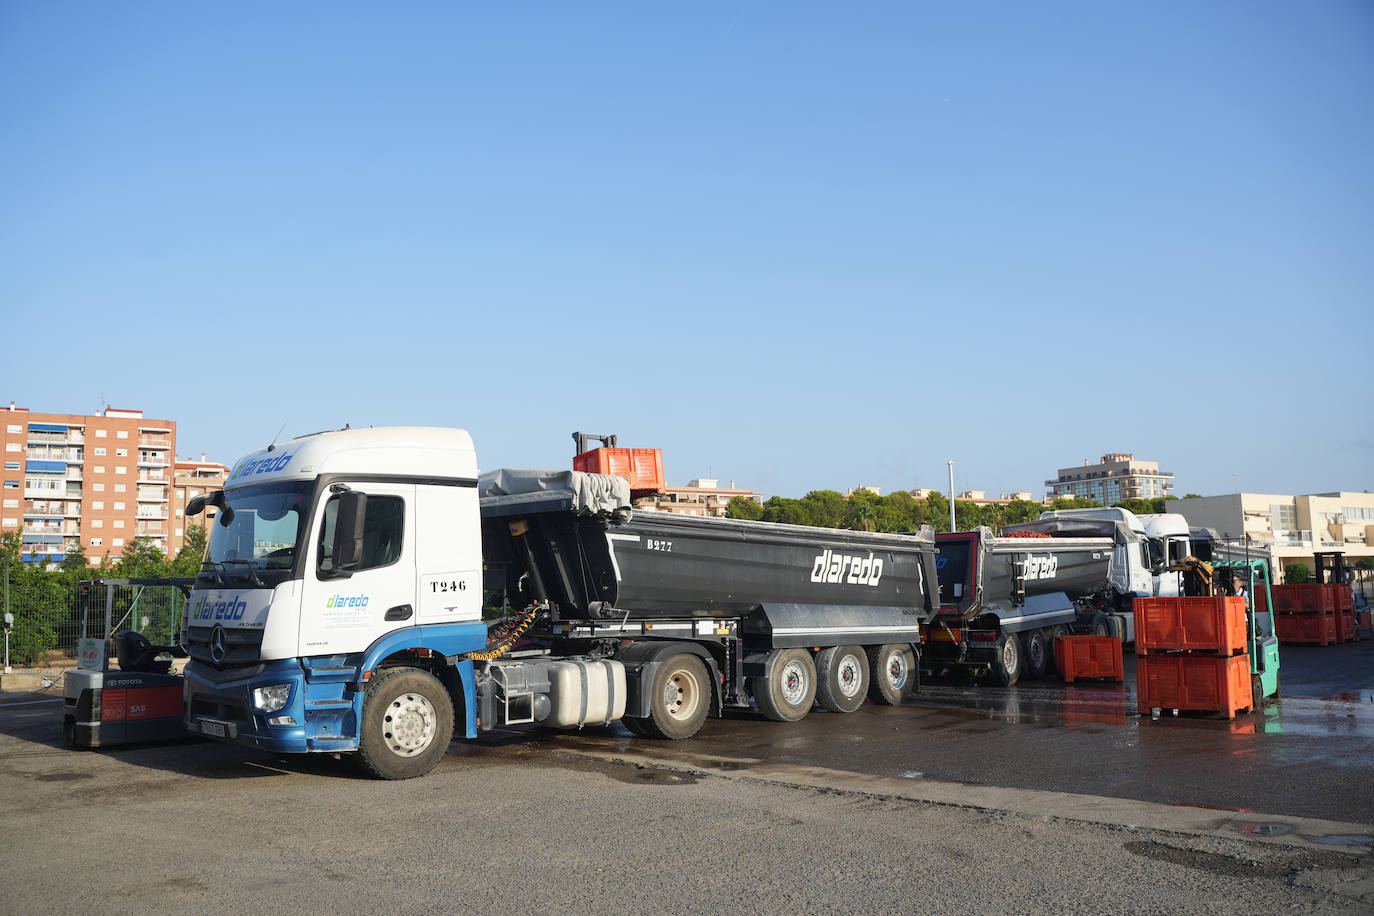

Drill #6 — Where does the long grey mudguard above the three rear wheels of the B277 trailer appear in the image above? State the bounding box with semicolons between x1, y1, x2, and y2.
742;604;921;650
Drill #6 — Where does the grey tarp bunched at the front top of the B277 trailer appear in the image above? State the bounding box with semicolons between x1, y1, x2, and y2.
477;467;631;525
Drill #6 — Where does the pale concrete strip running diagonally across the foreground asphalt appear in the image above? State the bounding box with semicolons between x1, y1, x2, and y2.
561;748;1374;856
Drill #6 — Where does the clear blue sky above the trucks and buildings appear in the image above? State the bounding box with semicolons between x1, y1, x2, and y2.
0;0;1374;496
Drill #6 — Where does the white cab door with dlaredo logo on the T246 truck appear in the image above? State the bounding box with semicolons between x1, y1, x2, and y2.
300;483;415;658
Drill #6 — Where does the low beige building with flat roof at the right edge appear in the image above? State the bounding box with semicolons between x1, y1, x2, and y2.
1165;492;1374;577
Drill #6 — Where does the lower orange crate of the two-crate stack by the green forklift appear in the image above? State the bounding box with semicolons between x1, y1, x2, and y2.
1135;654;1254;718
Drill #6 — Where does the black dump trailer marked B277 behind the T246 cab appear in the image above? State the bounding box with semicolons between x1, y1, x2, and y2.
480;470;940;737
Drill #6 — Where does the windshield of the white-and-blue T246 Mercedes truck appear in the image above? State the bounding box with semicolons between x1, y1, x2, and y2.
201;483;312;585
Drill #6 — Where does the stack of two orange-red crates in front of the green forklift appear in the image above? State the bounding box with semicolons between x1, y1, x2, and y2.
1134;596;1253;718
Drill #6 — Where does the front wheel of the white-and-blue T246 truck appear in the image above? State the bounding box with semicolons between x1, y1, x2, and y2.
356;667;453;779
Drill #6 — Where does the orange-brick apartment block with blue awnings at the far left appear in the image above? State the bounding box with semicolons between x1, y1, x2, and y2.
0;401;176;563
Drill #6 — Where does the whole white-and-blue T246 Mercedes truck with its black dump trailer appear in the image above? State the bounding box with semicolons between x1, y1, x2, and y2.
181;427;938;779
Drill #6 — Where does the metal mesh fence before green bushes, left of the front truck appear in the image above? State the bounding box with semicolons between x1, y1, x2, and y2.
2;578;191;667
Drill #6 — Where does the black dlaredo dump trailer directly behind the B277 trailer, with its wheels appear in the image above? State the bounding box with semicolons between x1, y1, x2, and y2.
921;527;1117;687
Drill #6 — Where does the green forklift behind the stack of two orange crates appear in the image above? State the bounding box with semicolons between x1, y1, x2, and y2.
1169;556;1279;710
